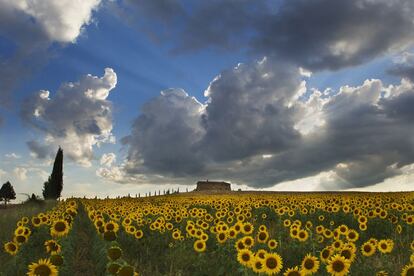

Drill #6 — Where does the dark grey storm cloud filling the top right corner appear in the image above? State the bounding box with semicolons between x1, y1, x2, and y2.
252;0;414;70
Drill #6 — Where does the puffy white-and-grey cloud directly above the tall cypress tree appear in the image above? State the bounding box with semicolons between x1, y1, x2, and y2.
22;68;117;166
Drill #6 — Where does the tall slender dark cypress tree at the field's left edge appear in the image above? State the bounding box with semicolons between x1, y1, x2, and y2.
43;147;63;200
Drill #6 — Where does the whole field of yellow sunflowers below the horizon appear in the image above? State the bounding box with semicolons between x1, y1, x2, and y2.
0;192;414;276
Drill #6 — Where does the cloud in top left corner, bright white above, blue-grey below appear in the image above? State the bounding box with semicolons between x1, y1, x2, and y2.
0;0;100;122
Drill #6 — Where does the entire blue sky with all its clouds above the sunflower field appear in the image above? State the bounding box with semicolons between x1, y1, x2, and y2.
0;0;414;198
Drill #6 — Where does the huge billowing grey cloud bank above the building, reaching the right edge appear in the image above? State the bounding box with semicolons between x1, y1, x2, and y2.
115;56;414;190
